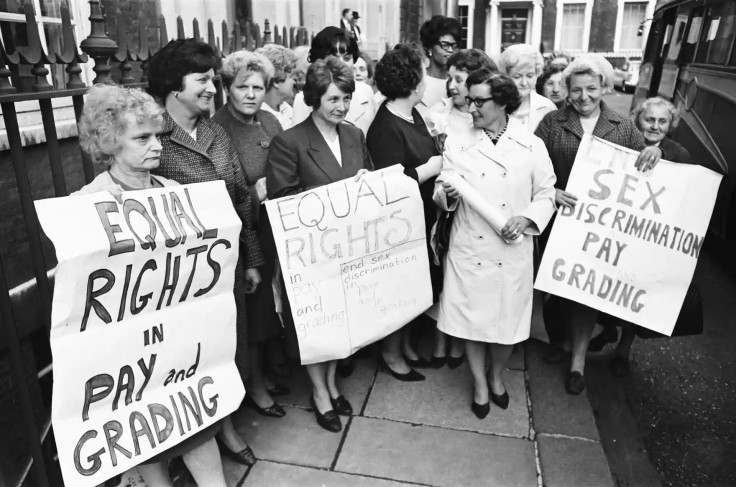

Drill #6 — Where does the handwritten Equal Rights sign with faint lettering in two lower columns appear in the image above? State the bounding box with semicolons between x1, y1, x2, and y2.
266;166;432;364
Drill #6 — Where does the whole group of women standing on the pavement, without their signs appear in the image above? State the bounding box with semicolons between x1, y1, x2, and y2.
72;16;689;486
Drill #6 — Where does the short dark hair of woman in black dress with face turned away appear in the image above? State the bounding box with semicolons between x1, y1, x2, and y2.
373;44;423;100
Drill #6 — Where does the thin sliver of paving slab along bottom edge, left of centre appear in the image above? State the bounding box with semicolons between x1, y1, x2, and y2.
244;461;411;487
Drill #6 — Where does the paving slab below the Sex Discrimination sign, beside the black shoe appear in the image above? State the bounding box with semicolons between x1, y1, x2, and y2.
526;340;600;441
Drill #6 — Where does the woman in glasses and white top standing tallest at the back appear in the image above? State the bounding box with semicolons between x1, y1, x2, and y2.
417;15;462;117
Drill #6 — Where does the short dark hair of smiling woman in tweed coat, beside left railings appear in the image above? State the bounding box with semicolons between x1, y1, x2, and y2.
148;39;222;102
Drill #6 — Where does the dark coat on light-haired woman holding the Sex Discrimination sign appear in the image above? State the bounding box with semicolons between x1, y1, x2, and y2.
534;101;645;189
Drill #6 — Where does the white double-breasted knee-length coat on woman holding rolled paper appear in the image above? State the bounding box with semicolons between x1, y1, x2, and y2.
434;119;556;345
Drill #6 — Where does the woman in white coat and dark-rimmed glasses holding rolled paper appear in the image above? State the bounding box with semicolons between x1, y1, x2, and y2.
434;69;556;418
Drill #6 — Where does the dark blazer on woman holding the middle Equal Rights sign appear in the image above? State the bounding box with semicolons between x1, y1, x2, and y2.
266;116;373;198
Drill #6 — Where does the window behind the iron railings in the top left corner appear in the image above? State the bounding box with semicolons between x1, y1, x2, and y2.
0;0;74;91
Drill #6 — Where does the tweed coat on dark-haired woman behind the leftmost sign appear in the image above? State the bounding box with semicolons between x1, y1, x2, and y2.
152;112;264;379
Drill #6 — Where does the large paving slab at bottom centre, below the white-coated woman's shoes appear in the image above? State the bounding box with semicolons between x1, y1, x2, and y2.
335;417;537;487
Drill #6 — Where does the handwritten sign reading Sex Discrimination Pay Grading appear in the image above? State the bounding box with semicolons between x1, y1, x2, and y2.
535;138;721;335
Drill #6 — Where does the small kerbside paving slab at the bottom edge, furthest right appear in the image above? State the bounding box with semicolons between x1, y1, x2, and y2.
537;435;614;487
